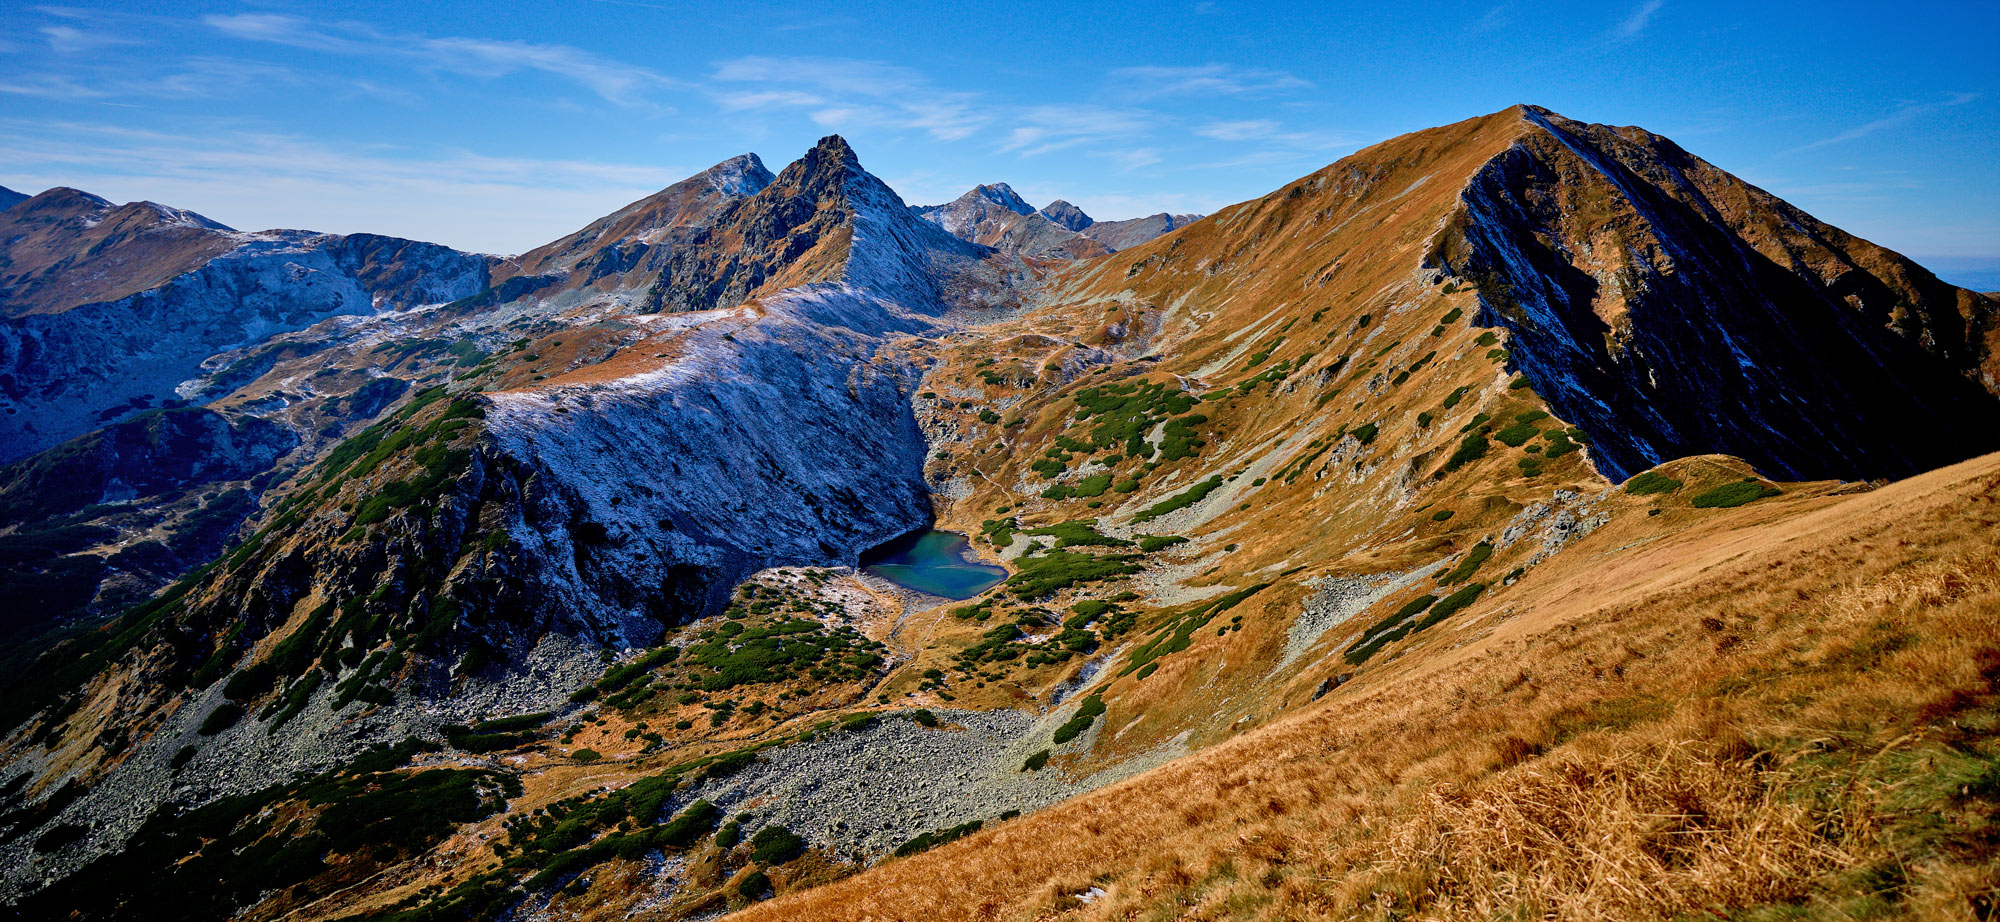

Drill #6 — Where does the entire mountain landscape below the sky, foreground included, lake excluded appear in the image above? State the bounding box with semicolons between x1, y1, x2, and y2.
0;106;2000;920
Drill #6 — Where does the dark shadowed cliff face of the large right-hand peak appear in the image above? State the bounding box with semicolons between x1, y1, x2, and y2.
1434;108;2000;480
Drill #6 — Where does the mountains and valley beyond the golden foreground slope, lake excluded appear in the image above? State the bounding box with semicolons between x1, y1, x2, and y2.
0;106;2000;918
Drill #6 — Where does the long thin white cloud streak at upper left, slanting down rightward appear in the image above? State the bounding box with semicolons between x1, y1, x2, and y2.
202;12;678;106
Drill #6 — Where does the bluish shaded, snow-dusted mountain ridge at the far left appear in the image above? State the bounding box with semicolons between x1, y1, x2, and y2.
0;199;486;460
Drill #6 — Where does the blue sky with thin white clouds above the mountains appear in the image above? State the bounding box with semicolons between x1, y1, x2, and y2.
0;0;2000;286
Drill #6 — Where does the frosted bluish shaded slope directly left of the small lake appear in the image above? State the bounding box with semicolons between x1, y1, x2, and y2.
488;294;930;644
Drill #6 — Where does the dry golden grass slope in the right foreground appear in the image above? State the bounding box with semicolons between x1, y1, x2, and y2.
740;456;2000;922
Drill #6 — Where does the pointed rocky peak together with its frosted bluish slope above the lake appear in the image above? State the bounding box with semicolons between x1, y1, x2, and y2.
466;138;968;644
